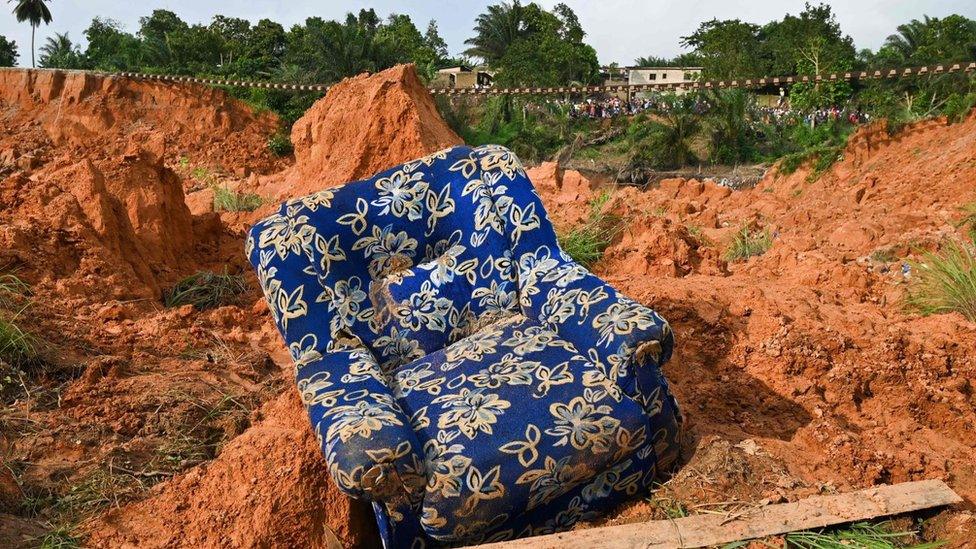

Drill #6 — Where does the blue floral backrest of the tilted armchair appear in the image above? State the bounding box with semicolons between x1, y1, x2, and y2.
251;146;558;370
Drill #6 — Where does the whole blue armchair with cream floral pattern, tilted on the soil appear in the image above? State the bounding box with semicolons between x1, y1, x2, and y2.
247;146;681;547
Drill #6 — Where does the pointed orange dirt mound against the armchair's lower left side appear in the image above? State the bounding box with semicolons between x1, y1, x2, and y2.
88;390;376;548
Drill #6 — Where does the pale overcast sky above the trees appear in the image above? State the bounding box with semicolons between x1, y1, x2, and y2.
0;0;976;65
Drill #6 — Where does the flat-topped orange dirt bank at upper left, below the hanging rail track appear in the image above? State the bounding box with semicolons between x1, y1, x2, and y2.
0;69;281;173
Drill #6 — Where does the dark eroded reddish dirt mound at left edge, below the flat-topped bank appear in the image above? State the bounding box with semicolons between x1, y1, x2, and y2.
0;133;200;302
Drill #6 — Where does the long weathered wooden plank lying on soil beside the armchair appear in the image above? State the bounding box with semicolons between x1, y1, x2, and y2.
479;480;962;549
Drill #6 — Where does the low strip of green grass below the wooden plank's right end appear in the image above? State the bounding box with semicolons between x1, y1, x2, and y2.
785;522;944;549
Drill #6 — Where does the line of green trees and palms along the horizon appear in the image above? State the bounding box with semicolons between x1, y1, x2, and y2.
0;0;976;120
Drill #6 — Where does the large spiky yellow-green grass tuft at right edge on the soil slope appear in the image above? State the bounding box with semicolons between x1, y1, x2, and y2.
905;241;976;321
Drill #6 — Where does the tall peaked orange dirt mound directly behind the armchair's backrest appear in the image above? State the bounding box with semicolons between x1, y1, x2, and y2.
257;65;461;200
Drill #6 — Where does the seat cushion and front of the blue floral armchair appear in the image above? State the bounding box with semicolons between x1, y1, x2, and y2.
391;315;654;541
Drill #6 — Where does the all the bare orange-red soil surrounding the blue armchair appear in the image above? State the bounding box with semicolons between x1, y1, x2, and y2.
0;67;976;547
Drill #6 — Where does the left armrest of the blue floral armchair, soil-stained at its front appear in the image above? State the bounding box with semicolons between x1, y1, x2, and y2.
246;211;426;506
